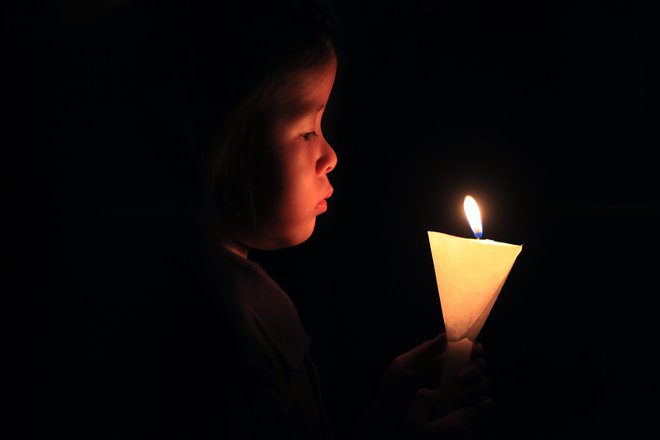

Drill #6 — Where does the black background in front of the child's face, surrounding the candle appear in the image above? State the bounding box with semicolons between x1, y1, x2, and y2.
262;1;658;438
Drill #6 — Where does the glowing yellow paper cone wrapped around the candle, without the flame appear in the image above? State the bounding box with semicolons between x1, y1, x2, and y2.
428;231;522;342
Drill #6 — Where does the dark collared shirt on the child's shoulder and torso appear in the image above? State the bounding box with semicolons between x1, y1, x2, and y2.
146;239;332;440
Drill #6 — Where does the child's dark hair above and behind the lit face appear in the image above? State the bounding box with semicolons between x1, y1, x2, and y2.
182;0;339;227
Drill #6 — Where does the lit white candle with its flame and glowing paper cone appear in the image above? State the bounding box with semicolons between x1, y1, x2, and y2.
428;196;522;413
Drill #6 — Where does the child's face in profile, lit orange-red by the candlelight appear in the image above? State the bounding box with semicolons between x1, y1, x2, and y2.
237;58;337;249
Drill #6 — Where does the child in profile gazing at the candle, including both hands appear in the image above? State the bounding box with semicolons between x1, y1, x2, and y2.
78;0;490;440
